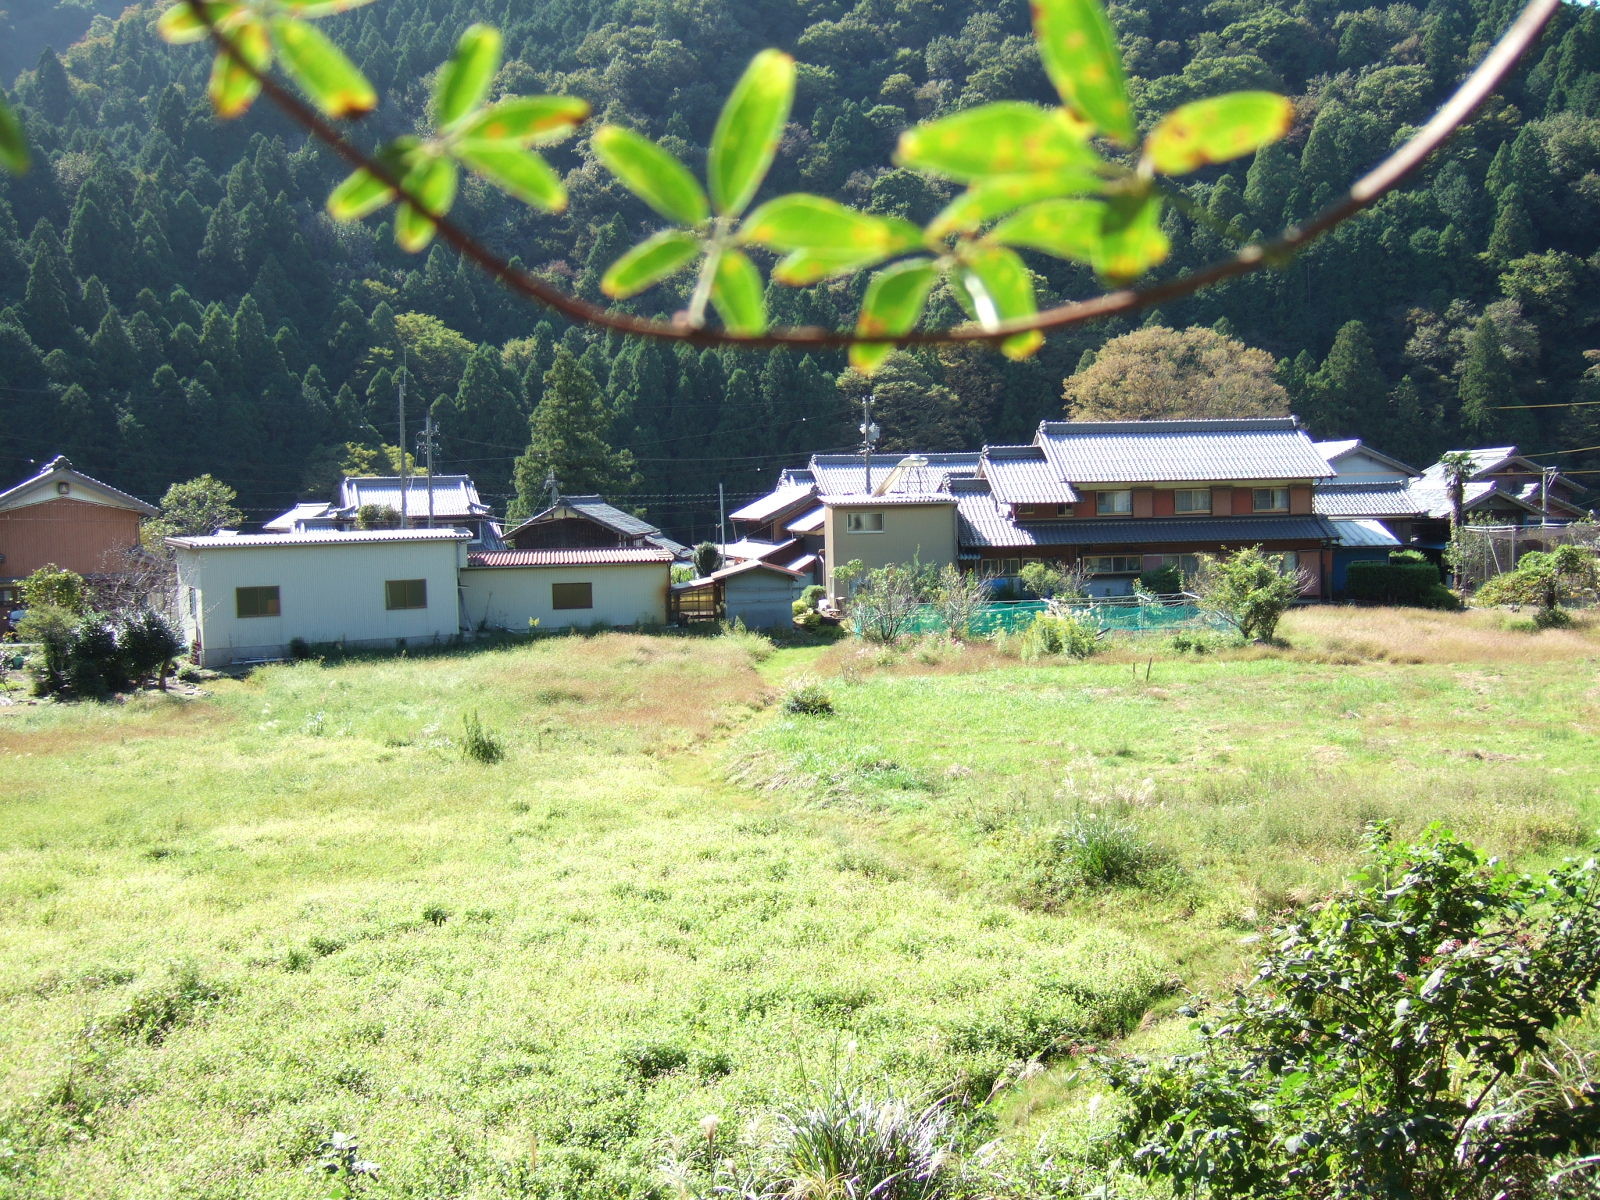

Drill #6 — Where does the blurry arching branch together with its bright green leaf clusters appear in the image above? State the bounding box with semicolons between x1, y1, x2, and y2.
90;0;1560;371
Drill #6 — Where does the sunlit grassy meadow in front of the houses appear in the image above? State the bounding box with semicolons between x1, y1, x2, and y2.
0;610;1600;1200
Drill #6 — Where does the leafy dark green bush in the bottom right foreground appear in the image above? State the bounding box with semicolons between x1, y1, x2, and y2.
1099;826;1600;1200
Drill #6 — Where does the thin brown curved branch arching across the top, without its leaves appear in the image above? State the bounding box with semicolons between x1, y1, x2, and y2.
182;0;1562;349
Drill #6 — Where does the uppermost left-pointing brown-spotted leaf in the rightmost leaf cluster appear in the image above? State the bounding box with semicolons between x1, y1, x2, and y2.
894;101;1102;184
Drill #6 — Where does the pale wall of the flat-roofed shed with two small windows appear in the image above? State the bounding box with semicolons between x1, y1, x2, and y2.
176;541;464;667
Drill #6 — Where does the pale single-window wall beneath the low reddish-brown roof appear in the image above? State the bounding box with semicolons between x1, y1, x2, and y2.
461;563;672;634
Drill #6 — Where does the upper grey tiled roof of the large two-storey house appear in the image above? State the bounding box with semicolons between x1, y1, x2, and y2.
1038;416;1334;485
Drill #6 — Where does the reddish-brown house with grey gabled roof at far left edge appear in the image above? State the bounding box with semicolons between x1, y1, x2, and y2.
0;458;155;611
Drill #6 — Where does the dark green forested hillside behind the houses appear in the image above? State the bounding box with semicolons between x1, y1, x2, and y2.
0;0;1600;536
